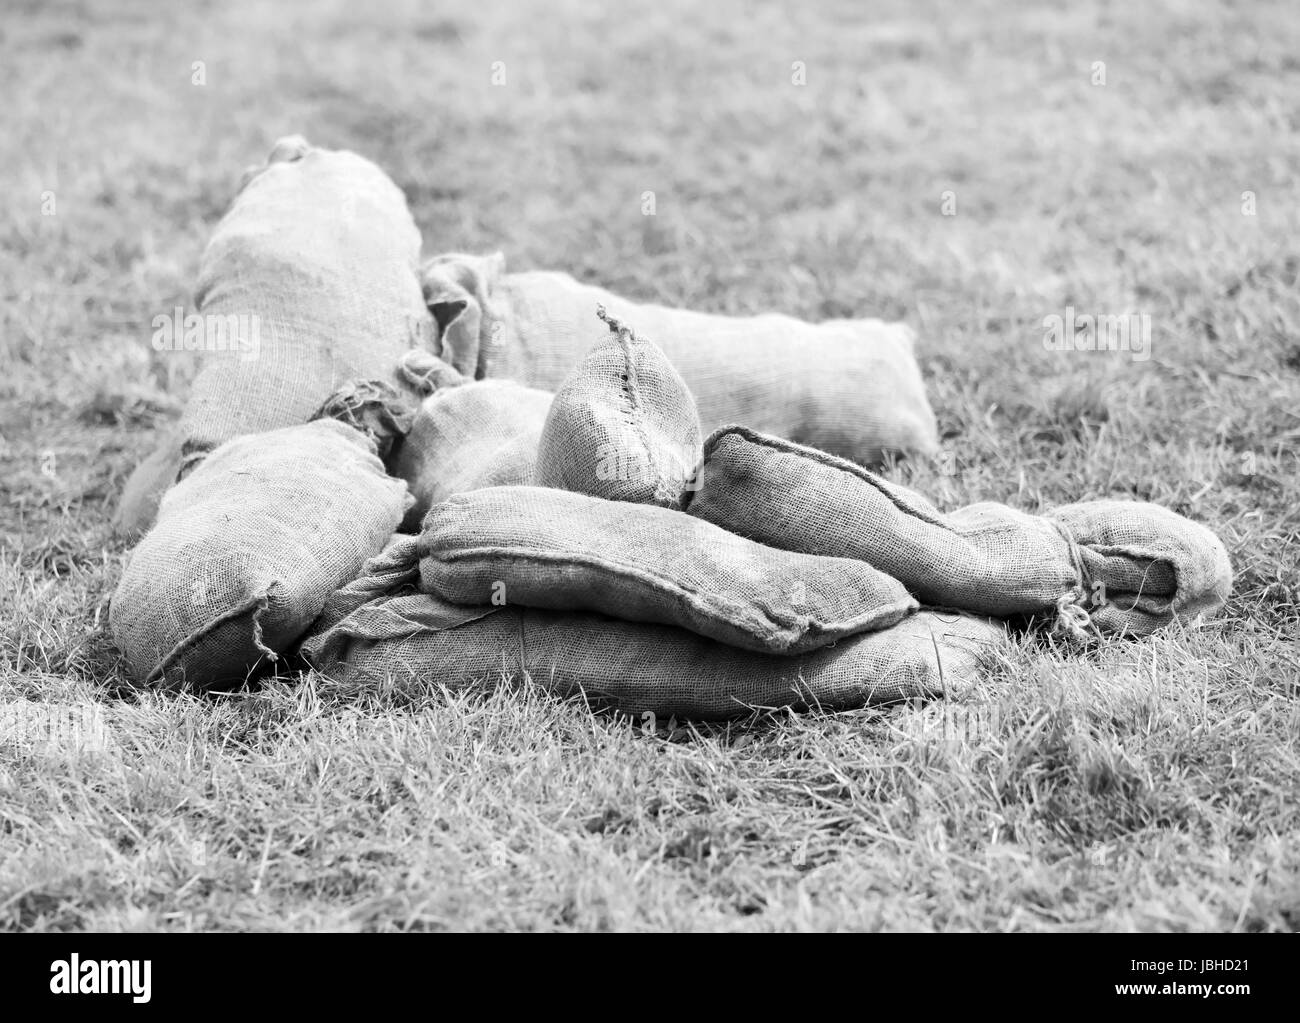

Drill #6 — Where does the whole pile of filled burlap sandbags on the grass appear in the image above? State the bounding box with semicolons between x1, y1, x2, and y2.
111;142;1231;718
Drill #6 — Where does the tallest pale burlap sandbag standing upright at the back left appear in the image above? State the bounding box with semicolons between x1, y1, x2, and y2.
116;136;434;536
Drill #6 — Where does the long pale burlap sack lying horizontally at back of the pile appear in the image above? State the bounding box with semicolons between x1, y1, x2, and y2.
424;253;937;464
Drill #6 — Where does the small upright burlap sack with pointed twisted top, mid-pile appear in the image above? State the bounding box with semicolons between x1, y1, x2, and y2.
536;307;703;508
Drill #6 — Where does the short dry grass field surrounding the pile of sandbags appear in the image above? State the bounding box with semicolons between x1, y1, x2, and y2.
0;0;1300;931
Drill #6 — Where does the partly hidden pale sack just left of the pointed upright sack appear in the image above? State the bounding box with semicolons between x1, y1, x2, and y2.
390;369;553;532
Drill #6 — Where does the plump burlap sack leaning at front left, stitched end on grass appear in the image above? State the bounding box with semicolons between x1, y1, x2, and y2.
109;420;407;689
